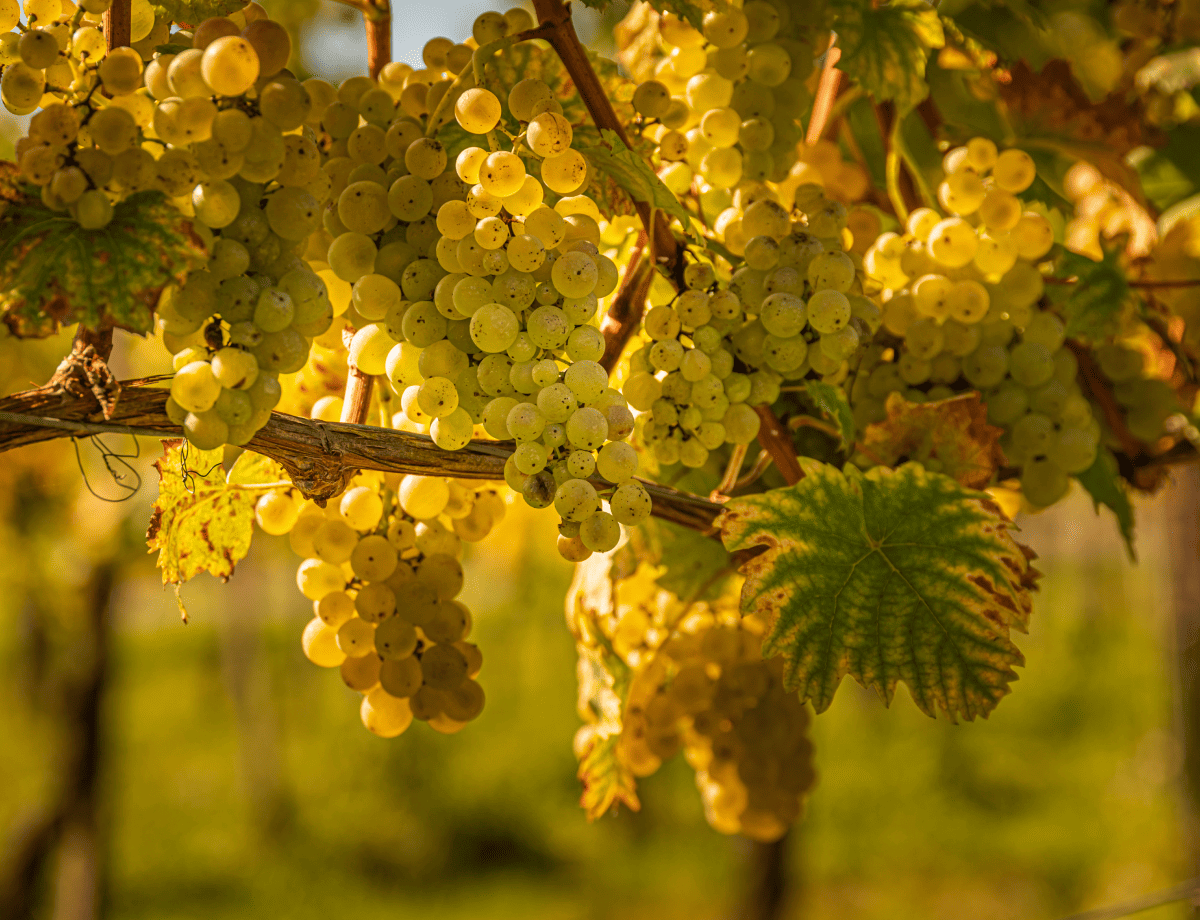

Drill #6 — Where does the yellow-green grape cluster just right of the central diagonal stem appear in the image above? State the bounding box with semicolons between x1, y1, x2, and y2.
624;184;880;467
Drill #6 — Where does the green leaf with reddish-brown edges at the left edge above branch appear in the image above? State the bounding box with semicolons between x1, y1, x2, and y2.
0;167;205;338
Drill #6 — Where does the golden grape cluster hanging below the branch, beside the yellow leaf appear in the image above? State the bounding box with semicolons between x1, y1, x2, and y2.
272;474;496;738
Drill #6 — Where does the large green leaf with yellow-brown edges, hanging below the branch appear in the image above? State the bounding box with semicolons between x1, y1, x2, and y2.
719;458;1036;720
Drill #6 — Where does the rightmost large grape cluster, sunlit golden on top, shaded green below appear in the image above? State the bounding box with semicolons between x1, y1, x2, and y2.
851;138;1100;506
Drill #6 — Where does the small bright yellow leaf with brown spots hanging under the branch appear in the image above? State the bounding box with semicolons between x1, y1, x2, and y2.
146;440;258;599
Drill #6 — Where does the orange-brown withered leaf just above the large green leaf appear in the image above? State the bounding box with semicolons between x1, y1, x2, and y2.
862;392;1004;488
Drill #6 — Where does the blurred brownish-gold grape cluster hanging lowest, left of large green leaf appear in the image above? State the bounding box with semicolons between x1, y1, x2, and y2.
618;605;815;841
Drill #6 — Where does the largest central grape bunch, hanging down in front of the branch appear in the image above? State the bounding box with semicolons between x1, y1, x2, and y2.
309;23;650;568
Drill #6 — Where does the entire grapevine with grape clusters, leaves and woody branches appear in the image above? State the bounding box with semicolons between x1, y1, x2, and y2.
0;0;1200;858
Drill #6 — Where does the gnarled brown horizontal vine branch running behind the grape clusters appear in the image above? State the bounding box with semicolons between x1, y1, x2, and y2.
0;383;721;534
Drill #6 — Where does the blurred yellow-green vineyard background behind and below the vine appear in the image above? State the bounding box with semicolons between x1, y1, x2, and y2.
0;0;1196;920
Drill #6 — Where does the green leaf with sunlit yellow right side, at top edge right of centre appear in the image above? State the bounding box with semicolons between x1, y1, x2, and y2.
833;0;946;113
